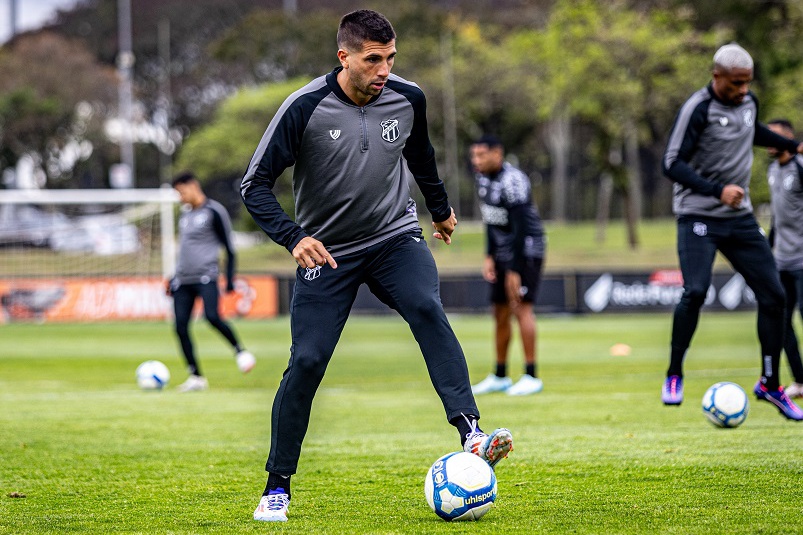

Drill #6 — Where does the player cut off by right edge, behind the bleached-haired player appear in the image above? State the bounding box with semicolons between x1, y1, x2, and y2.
767;119;803;398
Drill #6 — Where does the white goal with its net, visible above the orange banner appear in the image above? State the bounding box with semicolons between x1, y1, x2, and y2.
0;187;179;278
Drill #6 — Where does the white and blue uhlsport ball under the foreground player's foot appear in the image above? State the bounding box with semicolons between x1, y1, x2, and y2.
424;451;496;520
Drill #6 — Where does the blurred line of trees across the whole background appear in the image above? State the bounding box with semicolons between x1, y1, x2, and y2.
0;0;803;245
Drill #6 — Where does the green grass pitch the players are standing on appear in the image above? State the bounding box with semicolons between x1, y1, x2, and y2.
0;312;803;535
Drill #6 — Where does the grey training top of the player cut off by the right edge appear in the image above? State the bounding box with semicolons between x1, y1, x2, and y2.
767;154;803;271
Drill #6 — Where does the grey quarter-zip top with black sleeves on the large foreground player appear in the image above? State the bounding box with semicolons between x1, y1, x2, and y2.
241;67;451;256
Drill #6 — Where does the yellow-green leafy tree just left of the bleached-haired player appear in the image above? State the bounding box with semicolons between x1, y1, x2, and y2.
509;0;722;247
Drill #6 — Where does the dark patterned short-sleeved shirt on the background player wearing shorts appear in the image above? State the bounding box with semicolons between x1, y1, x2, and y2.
474;162;545;272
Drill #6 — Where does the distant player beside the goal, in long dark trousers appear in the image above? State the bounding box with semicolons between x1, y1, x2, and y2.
167;172;256;392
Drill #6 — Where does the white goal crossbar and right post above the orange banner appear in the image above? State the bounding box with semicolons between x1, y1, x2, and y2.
0;186;179;277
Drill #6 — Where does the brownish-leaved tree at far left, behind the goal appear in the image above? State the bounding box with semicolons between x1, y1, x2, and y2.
0;32;117;187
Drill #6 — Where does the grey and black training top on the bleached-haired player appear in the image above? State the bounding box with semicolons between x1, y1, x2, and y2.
662;84;797;218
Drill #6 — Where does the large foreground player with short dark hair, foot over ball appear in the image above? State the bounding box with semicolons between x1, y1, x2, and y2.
241;10;513;521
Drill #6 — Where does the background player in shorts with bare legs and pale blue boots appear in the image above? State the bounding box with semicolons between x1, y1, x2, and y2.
469;135;545;396
